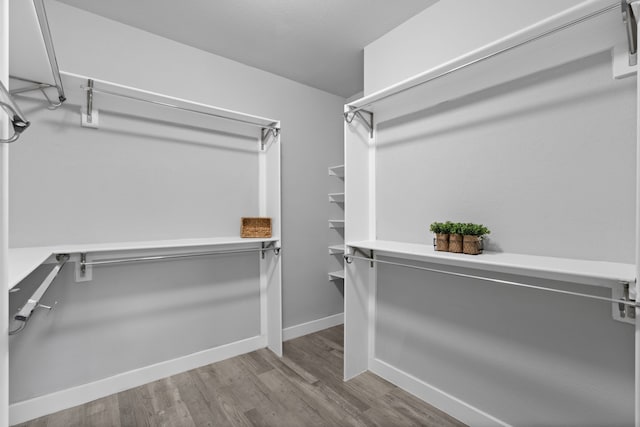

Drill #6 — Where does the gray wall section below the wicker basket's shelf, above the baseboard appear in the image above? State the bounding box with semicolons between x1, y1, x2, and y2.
9;254;260;403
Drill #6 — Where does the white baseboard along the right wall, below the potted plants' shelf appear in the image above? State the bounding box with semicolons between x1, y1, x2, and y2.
369;359;511;427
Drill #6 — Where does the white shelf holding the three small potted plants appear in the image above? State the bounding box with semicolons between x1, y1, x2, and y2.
347;240;636;287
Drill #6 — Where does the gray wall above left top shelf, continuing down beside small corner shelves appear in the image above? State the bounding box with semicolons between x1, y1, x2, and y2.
30;2;343;327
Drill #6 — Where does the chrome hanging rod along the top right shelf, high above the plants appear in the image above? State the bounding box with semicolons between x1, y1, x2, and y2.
344;2;620;118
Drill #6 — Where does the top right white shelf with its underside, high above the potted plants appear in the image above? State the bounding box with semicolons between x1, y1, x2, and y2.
345;0;626;122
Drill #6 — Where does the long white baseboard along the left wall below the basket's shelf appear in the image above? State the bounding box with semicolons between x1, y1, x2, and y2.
9;336;267;425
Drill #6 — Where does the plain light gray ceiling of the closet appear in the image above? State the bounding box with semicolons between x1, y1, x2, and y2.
59;0;438;98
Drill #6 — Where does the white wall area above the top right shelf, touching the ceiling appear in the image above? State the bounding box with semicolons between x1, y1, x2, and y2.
364;0;582;95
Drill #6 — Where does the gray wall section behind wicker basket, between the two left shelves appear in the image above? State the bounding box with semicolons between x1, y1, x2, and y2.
10;93;259;247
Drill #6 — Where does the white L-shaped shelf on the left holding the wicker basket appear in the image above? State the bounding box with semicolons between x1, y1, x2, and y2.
8;237;279;289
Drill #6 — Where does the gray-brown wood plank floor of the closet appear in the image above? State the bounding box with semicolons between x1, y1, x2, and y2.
15;326;464;427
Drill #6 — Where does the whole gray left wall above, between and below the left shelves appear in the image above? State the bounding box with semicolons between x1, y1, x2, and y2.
11;1;343;402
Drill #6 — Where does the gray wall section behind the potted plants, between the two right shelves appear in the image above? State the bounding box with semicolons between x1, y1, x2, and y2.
376;52;636;263
